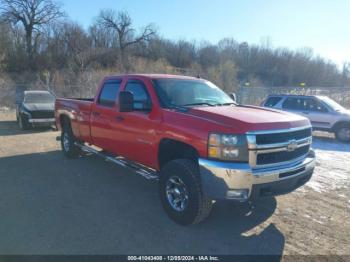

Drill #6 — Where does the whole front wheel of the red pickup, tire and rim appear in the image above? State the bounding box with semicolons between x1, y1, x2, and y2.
159;159;212;225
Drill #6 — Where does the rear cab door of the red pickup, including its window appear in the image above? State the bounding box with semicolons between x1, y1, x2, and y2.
90;79;122;151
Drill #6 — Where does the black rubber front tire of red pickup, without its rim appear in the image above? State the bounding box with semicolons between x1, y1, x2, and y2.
159;159;212;225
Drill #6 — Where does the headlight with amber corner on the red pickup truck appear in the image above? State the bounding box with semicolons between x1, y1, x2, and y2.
208;134;248;162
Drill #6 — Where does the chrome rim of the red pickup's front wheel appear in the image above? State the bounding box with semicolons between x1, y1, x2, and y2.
166;176;188;212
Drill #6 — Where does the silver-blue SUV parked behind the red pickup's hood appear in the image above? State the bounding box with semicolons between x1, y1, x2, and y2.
262;95;350;142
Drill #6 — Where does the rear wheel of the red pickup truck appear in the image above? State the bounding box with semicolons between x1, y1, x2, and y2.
61;121;80;158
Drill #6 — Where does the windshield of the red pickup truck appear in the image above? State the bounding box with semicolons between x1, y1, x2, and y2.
154;79;236;108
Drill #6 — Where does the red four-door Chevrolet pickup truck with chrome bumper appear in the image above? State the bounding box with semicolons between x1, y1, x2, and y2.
55;74;315;225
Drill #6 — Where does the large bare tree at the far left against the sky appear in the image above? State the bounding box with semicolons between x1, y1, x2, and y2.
0;0;64;66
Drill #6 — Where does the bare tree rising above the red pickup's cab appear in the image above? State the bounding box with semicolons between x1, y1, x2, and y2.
97;9;156;67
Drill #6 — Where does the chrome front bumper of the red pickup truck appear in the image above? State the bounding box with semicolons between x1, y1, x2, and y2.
199;150;316;201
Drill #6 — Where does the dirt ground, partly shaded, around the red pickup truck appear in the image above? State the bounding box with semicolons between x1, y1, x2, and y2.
0;111;350;258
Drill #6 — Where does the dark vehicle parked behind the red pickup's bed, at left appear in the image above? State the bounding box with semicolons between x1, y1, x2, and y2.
16;91;55;130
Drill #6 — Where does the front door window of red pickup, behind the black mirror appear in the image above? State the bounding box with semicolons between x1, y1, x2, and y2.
125;81;151;111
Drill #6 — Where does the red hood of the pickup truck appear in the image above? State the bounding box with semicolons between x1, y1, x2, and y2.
188;105;310;133
